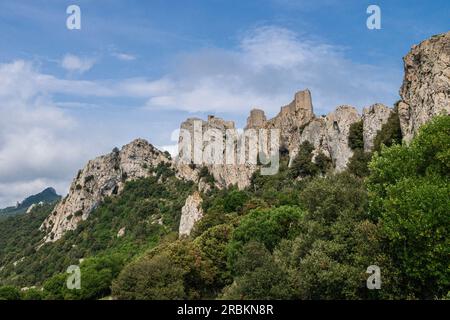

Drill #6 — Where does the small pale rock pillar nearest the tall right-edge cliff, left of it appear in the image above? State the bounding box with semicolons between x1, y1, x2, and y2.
362;103;393;152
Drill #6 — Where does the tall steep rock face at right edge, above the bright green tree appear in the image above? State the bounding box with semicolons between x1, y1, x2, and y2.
398;32;450;141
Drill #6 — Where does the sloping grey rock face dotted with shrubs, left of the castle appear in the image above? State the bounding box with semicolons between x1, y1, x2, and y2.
41;139;170;242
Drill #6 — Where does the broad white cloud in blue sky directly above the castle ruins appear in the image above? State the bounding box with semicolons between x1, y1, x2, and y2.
142;26;400;115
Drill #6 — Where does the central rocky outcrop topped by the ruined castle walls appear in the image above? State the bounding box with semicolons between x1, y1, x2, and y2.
178;90;364;185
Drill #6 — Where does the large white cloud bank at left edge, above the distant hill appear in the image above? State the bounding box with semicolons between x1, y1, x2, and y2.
0;61;105;207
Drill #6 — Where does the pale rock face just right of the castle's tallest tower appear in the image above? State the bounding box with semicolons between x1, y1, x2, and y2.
325;106;361;172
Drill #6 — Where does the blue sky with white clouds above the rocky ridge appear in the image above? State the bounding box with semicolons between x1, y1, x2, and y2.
0;0;450;207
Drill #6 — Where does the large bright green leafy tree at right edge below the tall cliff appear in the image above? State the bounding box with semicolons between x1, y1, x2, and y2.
368;116;450;298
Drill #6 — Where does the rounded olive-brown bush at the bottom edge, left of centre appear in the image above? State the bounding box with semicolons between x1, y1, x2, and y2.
112;241;214;300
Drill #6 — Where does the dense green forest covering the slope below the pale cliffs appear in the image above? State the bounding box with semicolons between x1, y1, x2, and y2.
0;113;450;299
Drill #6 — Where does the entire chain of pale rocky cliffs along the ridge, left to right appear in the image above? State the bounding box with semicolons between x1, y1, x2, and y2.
41;32;450;241
